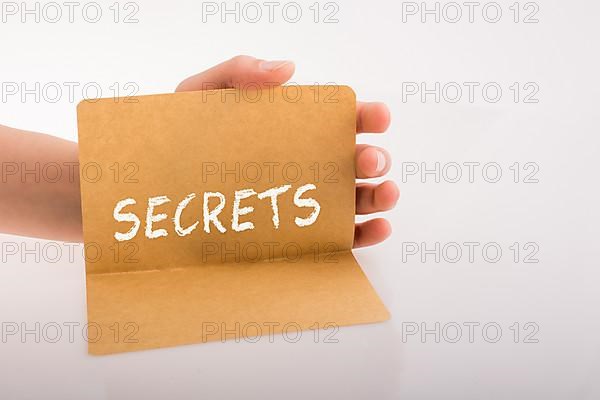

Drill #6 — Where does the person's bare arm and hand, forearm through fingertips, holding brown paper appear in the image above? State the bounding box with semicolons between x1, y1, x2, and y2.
0;56;399;248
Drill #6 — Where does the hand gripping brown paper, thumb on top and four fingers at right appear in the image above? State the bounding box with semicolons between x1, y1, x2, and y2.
176;56;400;248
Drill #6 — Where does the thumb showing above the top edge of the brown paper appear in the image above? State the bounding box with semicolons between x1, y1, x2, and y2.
175;56;295;92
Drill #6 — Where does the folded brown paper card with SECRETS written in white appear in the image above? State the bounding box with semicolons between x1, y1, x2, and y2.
78;86;389;354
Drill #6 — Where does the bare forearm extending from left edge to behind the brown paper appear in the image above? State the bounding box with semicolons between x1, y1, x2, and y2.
0;125;82;242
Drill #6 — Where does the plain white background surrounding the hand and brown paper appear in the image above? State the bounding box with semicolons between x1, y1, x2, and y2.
0;0;600;399
